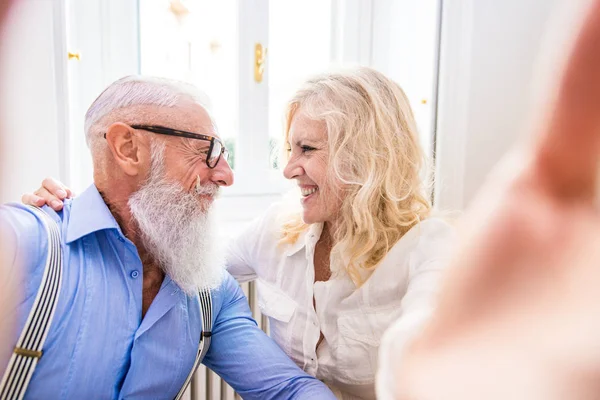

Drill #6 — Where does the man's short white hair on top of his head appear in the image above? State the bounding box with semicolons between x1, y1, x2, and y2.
84;75;209;153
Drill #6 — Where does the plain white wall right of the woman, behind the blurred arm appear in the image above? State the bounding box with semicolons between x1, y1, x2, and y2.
436;0;581;210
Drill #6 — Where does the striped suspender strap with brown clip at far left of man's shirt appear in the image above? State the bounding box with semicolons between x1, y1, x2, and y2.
0;207;62;400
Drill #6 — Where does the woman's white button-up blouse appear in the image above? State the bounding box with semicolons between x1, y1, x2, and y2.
227;205;454;399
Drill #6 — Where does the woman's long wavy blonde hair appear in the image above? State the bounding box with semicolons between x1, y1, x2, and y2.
280;67;431;286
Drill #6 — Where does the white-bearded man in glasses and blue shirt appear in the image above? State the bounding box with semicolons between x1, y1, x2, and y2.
0;77;334;399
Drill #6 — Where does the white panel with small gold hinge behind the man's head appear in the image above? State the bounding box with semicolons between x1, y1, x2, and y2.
64;0;139;193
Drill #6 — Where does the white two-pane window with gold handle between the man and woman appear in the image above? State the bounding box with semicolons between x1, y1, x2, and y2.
139;0;354;233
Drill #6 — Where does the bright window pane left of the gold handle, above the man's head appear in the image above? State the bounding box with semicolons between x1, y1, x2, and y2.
140;0;238;167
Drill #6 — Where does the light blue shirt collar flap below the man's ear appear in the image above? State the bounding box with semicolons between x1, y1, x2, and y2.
66;185;121;243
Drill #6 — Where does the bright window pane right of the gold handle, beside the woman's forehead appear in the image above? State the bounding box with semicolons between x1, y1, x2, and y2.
268;0;332;167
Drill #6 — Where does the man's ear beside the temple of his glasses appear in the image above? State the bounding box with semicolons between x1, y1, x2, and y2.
106;122;150;176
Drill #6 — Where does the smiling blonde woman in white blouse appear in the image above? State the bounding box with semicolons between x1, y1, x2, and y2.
24;68;454;399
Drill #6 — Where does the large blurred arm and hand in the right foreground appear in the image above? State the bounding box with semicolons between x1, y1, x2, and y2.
378;0;600;400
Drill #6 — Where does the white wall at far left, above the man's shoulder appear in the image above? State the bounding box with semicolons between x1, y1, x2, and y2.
0;0;67;202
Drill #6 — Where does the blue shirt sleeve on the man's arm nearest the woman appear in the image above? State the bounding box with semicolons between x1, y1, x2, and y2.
203;277;335;399
